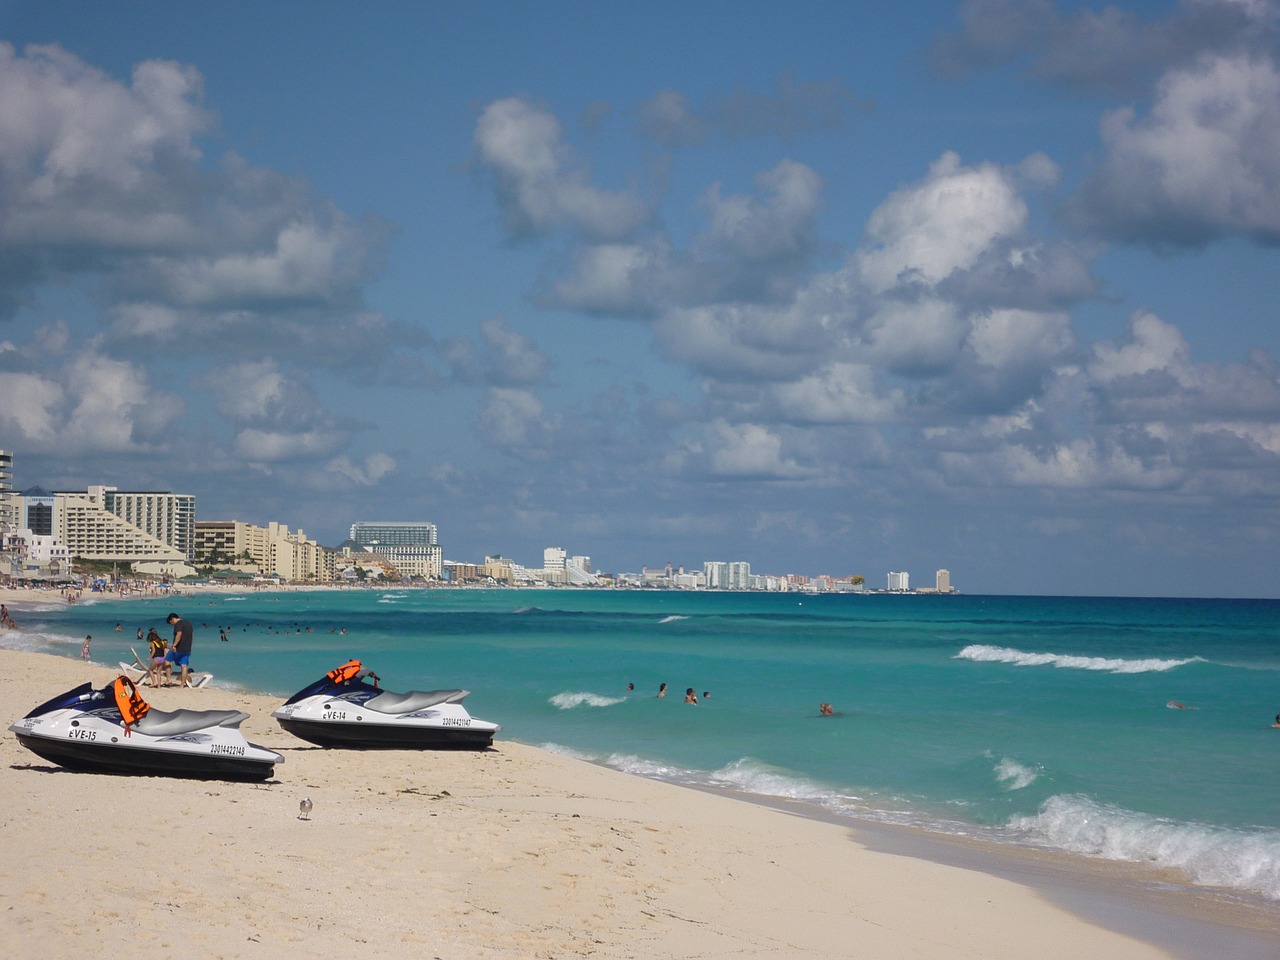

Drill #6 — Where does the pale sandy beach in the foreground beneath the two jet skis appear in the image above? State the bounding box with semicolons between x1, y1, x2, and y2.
0;650;1276;960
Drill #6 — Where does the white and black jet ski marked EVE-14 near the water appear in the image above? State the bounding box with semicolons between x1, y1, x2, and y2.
271;660;502;750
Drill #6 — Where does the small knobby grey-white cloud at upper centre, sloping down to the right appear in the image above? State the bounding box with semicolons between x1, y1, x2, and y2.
474;97;649;239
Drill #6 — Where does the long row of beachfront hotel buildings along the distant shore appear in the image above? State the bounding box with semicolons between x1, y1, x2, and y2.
0;449;956;594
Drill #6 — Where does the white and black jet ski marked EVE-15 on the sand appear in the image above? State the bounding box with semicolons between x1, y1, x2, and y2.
9;676;284;781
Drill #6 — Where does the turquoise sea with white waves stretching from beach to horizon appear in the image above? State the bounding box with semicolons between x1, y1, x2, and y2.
10;590;1280;900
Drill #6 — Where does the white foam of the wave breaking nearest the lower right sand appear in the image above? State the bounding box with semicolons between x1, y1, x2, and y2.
1009;795;1280;900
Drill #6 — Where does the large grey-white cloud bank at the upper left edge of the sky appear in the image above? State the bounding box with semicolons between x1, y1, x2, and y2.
0;44;399;370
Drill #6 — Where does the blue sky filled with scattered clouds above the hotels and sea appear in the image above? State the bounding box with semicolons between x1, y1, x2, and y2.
0;0;1280;596
